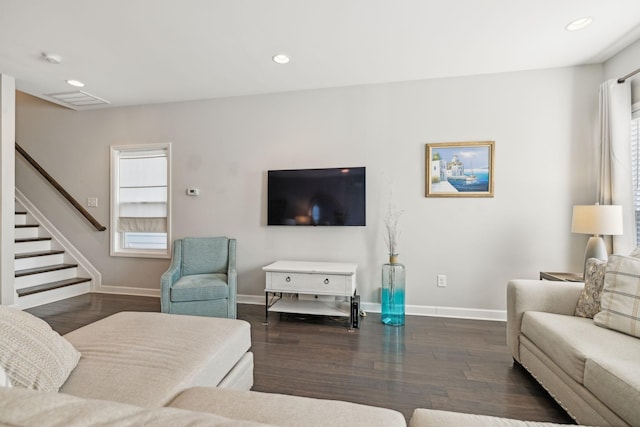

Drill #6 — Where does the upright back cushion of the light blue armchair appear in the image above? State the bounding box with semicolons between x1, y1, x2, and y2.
182;237;229;276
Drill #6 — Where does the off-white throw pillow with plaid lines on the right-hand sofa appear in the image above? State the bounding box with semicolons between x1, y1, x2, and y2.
593;255;640;338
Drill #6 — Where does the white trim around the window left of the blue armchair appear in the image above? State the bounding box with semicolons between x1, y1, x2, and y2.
109;142;173;258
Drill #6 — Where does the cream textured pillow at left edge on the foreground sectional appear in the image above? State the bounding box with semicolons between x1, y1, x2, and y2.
0;306;80;391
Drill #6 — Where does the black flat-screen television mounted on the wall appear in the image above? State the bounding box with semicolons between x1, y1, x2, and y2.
267;167;366;226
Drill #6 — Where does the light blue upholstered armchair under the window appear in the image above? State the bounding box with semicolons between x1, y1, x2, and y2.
160;237;238;319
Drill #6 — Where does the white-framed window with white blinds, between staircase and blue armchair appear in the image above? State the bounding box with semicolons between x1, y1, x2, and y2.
111;144;171;257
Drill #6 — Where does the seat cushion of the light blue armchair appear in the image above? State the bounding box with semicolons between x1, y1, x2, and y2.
171;273;229;302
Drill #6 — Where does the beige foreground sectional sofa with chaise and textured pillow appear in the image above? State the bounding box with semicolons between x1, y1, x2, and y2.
0;306;592;427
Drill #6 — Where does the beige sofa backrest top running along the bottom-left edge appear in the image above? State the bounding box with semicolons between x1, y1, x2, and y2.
0;388;272;427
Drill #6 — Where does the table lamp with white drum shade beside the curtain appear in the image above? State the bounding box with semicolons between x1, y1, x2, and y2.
571;203;622;271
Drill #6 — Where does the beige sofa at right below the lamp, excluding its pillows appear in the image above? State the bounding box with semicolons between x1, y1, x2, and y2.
507;280;640;426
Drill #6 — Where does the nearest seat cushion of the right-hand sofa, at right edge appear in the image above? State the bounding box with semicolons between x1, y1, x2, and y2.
584;358;640;425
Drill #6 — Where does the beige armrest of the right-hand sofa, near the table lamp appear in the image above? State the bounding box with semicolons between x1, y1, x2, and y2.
507;279;584;362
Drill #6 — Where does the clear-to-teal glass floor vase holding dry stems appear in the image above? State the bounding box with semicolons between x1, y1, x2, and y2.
381;255;405;326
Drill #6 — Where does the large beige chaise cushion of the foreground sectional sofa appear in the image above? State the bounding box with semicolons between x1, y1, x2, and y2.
60;312;251;406
